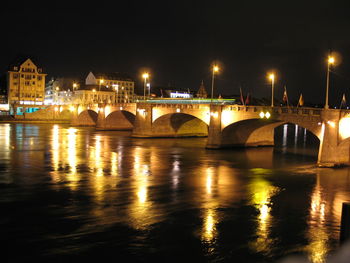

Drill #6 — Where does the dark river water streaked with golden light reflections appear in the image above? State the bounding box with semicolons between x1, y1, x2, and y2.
0;124;350;262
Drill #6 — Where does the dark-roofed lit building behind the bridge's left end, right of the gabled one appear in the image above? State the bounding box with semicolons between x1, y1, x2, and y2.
85;72;135;103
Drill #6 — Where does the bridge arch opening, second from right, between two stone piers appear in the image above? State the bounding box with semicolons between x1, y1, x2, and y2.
152;113;208;137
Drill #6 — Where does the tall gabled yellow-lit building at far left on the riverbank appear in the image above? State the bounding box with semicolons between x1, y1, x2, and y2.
7;58;46;115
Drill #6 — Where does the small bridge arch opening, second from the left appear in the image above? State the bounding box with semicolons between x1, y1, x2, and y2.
104;110;136;130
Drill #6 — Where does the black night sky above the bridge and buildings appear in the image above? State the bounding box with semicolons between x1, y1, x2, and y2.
0;0;350;106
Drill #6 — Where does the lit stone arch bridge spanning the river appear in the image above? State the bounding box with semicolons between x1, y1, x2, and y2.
32;102;350;167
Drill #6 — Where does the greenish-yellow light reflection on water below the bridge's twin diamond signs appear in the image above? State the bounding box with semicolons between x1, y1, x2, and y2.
249;175;279;254
